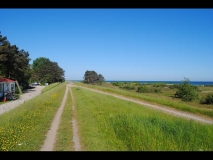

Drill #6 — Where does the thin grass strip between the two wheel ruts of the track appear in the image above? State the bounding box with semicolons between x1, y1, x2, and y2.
53;87;74;151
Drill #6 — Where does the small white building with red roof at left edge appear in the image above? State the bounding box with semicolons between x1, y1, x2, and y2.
0;77;15;97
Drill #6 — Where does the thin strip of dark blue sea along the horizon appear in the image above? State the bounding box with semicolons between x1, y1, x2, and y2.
70;80;213;86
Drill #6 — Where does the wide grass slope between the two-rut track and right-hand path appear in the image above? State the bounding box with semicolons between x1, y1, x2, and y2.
72;87;213;151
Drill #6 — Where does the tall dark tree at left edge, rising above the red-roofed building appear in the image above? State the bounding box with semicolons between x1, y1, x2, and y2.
0;31;31;83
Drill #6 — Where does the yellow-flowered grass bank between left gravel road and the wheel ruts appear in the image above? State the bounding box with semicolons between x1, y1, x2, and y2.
0;83;66;151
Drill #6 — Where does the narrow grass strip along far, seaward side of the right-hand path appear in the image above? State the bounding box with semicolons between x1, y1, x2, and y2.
75;82;213;118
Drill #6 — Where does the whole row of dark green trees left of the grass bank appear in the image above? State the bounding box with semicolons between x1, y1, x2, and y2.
0;32;65;88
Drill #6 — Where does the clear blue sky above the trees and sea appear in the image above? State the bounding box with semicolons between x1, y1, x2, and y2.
0;8;213;81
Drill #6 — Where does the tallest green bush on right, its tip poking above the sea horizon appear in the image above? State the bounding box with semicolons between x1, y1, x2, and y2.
175;78;198;101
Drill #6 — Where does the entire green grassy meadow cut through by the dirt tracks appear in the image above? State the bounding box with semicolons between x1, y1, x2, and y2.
0;82;213;151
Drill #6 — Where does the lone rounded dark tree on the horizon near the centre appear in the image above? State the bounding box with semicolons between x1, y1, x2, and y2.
83;70;105;84
